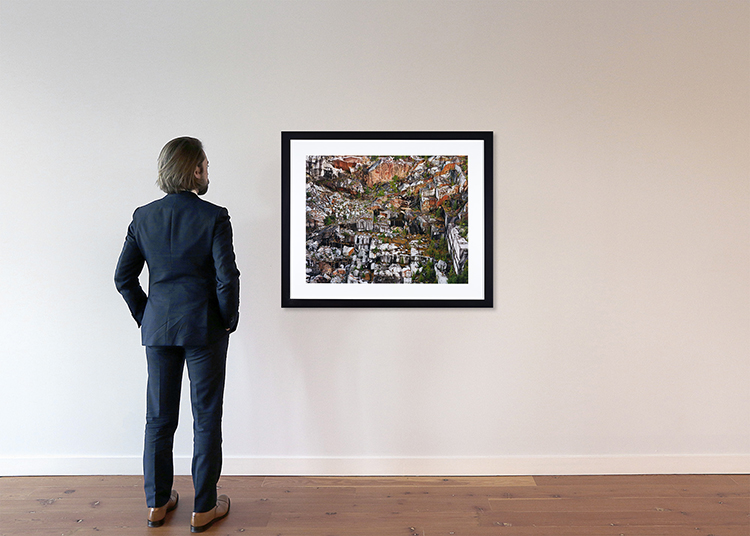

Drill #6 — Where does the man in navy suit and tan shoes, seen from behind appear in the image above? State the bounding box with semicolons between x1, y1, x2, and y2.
115;138;240;532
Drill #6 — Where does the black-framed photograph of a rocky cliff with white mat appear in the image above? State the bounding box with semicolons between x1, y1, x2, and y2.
281;132;493;307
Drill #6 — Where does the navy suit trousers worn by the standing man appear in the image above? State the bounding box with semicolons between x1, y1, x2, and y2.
143;335;229;512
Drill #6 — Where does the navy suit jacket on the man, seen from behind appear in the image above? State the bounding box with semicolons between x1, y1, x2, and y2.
115;192;240;346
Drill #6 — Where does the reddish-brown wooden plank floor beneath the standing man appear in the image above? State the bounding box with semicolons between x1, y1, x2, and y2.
0;475;750;536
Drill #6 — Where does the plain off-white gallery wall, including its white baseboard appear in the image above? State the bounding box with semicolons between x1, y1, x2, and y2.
0;0;750;475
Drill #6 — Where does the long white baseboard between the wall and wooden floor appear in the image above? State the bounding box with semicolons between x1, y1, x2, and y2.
0;454;750;476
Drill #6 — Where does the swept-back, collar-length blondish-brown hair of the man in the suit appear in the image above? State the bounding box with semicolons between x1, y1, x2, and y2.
156;137;206;194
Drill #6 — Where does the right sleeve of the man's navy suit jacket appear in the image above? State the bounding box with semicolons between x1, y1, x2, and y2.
213;208;240;333
